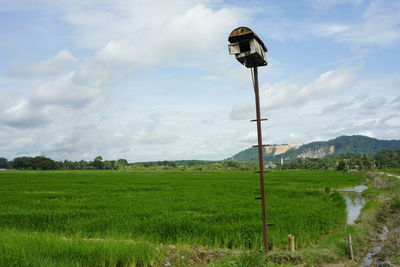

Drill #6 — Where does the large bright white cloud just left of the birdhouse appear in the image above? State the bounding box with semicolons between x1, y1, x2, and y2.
87;4;241;72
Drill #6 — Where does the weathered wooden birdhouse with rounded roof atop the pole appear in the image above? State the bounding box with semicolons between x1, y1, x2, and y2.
228;27;268;68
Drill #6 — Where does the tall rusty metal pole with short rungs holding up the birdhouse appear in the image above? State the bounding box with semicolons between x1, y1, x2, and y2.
253;67;268;253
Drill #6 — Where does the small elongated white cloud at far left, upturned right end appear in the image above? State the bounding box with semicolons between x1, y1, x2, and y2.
8;50;78;78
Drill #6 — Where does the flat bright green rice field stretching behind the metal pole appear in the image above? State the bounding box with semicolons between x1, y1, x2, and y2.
0;170;362;266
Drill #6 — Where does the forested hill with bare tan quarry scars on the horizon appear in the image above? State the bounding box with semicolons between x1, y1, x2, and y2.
232;135;400;161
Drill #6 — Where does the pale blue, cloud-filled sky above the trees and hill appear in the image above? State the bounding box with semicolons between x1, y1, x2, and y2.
0;0;400;162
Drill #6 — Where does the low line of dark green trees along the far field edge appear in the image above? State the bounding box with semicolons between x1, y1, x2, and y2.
0;150;400;171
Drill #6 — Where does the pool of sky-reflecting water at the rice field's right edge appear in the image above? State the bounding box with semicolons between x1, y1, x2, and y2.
339;185;368;224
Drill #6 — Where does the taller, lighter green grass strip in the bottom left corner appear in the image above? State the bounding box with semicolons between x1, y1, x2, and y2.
0;230;160;267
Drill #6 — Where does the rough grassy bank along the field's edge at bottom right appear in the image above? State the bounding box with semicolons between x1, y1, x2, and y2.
210;173;400;267
